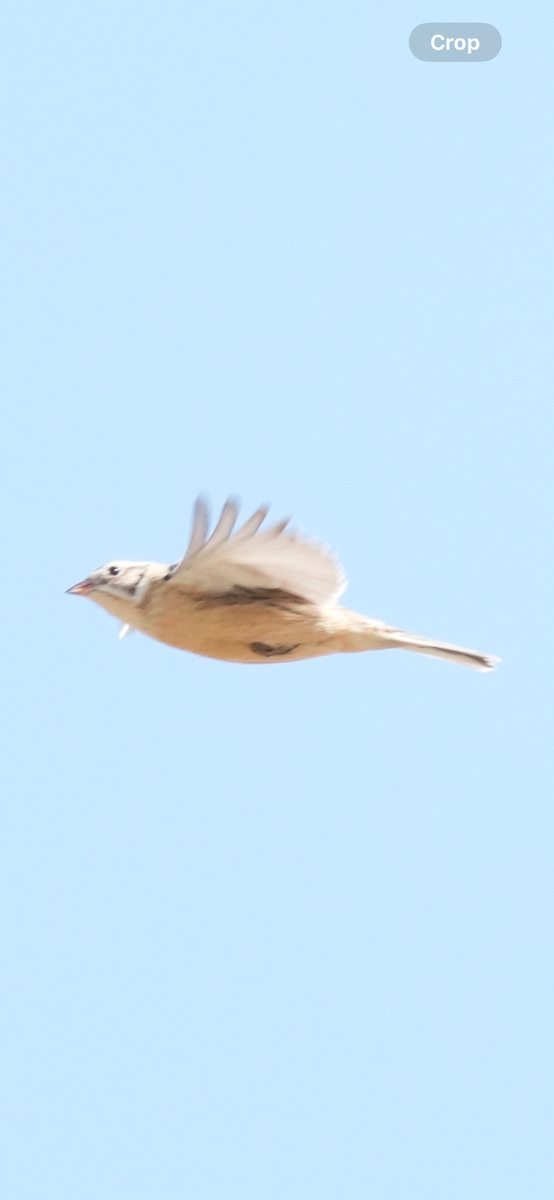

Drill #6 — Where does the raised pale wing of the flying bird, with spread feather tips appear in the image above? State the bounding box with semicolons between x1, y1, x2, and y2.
170;499;347;606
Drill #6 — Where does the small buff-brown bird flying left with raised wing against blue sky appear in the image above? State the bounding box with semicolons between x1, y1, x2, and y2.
68;498;500;671
